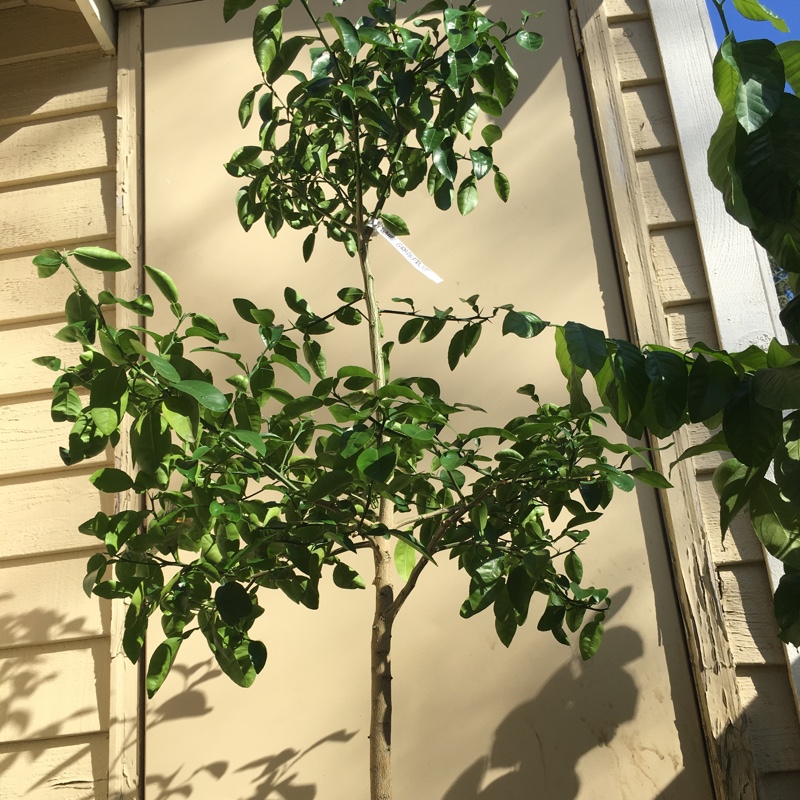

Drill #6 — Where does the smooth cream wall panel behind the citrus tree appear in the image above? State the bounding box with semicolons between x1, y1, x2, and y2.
145;0;711;800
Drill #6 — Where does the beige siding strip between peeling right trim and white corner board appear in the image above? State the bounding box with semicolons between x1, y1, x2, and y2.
580;0;800;800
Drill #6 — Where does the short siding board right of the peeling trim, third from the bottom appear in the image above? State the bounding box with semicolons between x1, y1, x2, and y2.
719;563;786;667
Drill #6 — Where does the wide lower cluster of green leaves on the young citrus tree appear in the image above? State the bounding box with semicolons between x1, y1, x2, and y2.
36;248;663;694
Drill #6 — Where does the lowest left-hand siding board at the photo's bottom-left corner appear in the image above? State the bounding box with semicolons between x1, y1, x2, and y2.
0;733;108;800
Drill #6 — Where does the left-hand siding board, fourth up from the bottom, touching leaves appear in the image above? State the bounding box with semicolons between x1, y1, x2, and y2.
0;467;114;564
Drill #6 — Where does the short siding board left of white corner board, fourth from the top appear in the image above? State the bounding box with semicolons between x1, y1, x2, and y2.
638;152;694;228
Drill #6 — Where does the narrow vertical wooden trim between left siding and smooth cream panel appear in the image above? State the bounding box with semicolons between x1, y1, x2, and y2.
108;10;144;800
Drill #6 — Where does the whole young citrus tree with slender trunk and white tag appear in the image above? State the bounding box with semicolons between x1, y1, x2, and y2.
31;0;667;800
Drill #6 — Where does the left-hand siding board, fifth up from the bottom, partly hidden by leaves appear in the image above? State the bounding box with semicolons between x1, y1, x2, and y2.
0;398;108;477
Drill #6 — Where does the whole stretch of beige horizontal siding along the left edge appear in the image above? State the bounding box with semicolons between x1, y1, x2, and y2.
0;0;128;800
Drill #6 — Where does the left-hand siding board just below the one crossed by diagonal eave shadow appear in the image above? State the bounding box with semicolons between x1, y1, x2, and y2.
0;109;117;186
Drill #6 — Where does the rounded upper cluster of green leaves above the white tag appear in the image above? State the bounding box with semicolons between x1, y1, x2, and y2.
226;0;542;255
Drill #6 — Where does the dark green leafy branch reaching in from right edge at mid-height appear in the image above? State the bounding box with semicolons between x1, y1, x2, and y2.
556;316;800;644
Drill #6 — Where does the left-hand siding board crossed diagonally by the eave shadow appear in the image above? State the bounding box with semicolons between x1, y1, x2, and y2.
0;52;116;123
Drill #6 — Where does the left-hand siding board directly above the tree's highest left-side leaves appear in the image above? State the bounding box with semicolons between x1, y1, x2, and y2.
0;172;116;252
